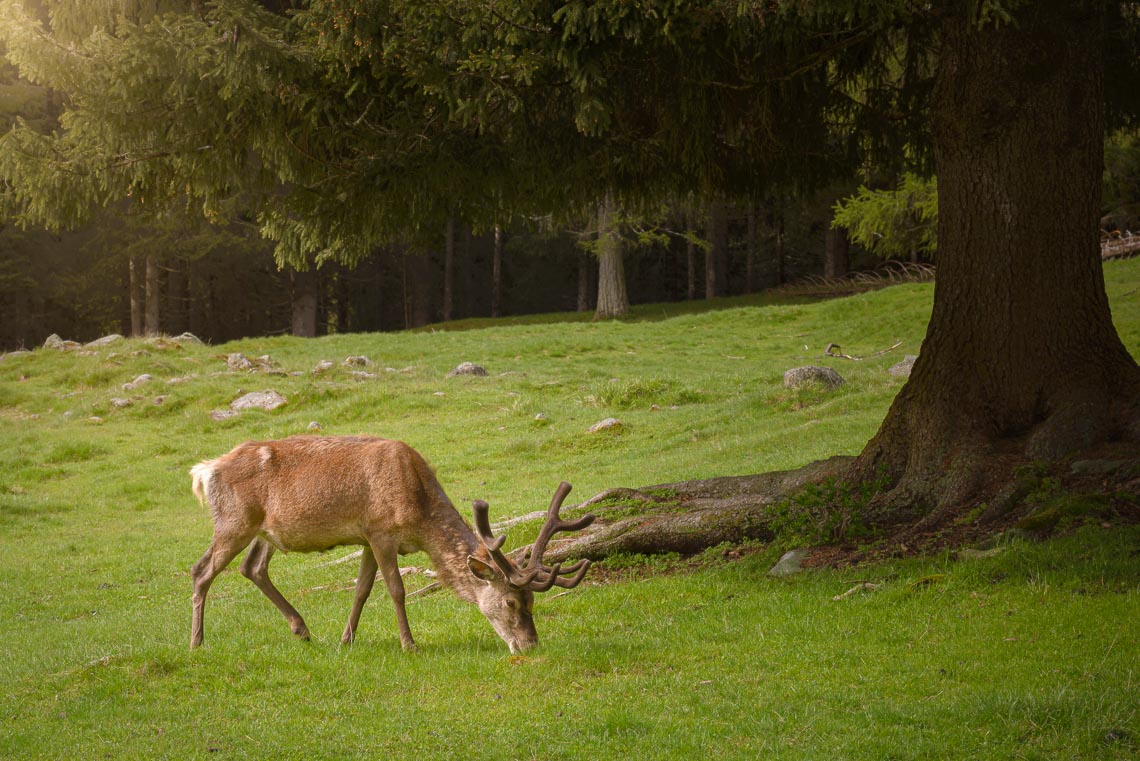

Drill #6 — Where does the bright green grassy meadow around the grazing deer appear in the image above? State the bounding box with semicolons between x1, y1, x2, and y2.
0;260;1140;760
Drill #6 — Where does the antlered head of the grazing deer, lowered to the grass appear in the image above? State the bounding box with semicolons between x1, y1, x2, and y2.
467;481;594;653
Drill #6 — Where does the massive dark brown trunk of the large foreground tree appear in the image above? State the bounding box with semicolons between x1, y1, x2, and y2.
854;0;1140;525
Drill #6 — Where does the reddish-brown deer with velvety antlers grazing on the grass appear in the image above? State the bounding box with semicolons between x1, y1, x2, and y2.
190;435;594;653
